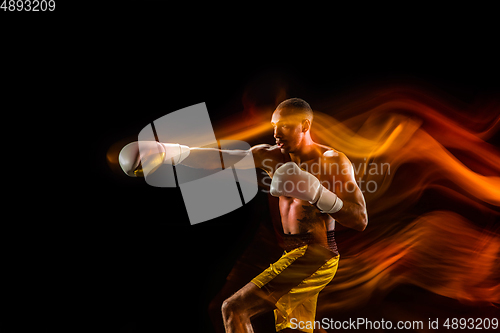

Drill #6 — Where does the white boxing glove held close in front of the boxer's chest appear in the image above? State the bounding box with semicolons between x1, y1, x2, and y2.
270;162;344;213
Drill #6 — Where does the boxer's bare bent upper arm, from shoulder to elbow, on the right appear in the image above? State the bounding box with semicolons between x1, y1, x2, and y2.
329;153;368;231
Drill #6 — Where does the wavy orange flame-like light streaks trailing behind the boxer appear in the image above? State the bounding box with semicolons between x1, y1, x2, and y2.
212;87;500;313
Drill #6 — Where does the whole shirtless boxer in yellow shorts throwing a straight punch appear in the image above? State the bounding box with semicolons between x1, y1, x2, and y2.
119;98;368;333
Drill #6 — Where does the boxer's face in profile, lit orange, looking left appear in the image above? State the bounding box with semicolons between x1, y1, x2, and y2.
271;109;305;153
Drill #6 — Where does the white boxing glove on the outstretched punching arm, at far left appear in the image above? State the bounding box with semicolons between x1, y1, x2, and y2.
118;141;190;177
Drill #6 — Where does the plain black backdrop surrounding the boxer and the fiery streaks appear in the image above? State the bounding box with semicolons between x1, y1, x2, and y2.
2;1;500;332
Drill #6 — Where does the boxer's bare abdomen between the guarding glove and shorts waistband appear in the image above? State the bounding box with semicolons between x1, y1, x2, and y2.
279;196;335;233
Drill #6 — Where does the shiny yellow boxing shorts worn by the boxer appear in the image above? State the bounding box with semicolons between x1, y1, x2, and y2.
252;244;340;333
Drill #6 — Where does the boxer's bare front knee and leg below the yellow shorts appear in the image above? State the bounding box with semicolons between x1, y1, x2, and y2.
222;282;276;333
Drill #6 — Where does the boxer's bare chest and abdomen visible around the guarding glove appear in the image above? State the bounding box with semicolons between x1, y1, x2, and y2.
262;145;335;238
